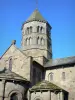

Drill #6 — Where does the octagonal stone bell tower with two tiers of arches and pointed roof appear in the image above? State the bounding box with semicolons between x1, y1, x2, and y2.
21;9;52;64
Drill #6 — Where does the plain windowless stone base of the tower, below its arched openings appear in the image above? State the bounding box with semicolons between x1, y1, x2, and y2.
23;49;51;65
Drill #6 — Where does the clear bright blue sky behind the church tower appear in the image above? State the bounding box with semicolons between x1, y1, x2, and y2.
0;0;75;59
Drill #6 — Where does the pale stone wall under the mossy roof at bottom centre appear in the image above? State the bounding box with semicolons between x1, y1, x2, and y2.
29;90;64;100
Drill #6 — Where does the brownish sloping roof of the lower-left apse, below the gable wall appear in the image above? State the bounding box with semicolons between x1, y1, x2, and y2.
0;68;27;81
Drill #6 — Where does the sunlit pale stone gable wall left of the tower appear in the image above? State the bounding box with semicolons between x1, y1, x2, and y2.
1;45;32;80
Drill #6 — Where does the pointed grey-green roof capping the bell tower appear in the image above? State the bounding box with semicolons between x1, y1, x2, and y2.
26;9;47;22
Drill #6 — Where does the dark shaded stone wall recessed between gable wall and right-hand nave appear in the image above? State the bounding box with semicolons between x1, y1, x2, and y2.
31;61;45;85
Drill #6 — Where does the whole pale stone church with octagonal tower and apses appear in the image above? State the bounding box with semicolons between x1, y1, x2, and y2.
0;9;75;100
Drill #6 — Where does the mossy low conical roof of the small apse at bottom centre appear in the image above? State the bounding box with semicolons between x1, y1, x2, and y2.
30;80;63;91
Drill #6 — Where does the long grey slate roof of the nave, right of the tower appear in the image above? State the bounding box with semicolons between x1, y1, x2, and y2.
44;56;75;68
